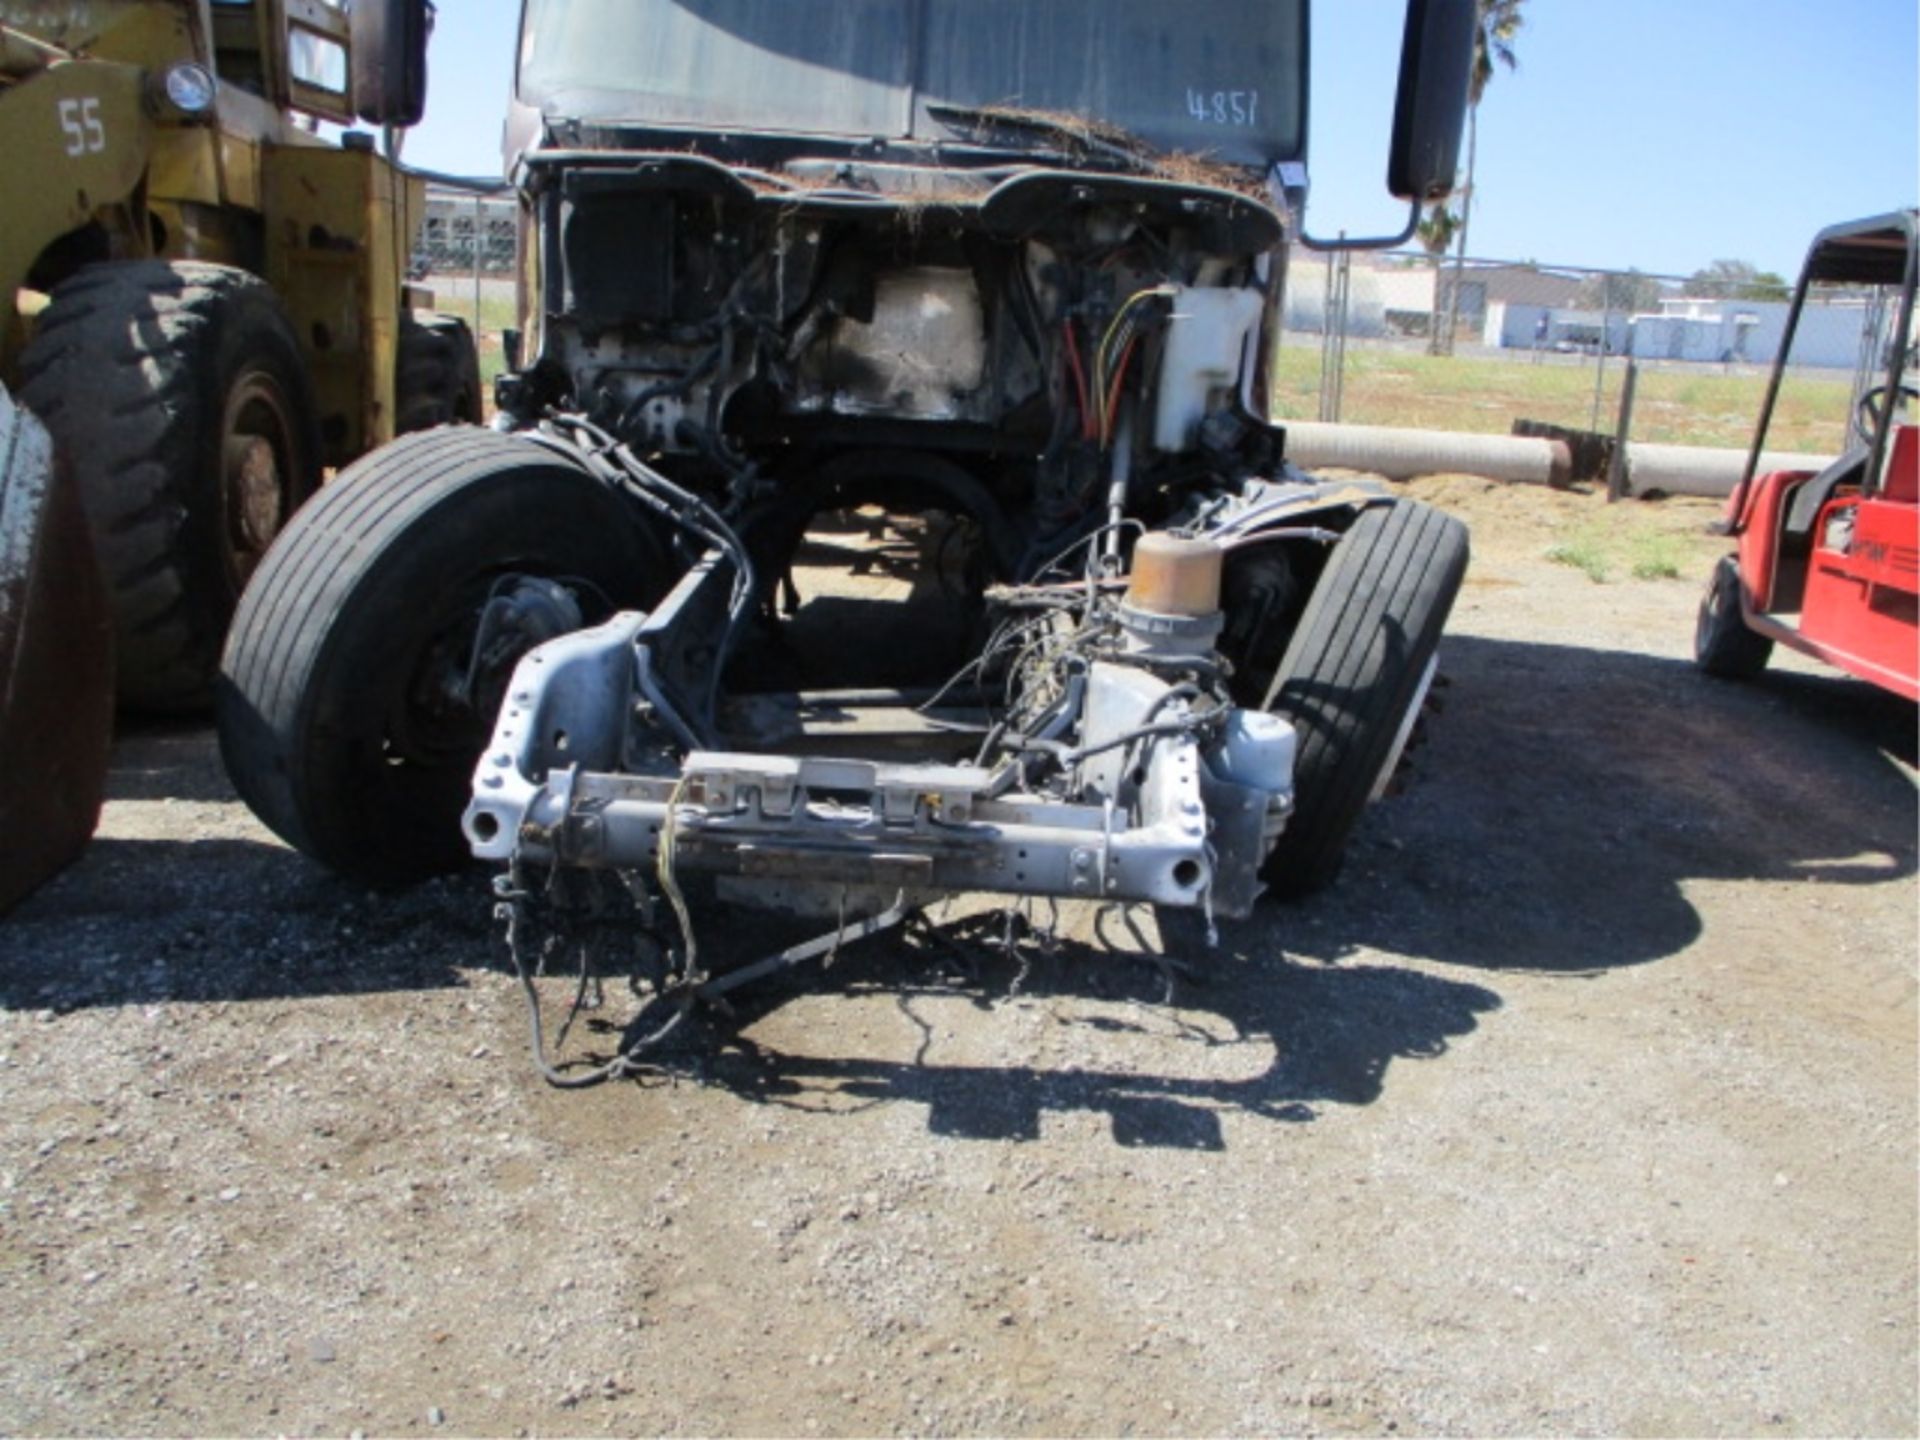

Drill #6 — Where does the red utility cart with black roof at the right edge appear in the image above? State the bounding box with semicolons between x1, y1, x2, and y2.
1693;209;1920;699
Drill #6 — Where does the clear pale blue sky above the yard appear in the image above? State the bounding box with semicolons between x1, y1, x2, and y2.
407;0;1920;275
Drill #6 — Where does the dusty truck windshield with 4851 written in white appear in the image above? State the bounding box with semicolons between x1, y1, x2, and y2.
518;0;1308;169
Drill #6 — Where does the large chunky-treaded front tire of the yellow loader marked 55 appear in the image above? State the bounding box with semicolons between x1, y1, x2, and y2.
19;259;321;712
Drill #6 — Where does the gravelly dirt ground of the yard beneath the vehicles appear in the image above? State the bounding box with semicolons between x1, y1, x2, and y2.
0;478;1920;1436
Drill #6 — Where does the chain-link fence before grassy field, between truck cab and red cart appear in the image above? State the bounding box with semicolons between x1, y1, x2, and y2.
1275;248;1893;478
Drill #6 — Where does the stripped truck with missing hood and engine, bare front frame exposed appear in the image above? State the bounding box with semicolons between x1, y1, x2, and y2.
221;0;1475;1068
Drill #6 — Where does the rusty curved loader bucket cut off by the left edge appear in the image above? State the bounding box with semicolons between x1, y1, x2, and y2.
0;386;113;912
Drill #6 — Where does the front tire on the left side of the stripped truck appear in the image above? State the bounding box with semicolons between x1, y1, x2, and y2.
215;426;672;883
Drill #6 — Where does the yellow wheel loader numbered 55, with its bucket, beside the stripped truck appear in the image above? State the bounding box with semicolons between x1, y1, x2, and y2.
0;0;480;906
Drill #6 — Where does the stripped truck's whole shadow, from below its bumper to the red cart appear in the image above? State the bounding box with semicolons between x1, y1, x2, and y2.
610;637;1916;1148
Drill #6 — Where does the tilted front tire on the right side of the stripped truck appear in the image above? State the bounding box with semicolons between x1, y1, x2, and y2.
1261;499;1467;897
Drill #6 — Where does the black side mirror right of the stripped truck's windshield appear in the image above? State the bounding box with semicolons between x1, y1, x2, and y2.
1386;0;1480;205
